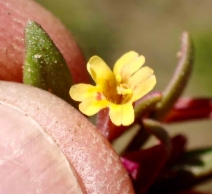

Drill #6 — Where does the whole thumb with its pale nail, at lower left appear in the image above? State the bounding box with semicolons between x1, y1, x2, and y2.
0;82;134;194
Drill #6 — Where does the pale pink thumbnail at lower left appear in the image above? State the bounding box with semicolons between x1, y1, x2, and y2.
0;103;85;194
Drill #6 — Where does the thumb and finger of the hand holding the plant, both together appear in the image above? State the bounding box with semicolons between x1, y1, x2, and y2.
0;0;134;194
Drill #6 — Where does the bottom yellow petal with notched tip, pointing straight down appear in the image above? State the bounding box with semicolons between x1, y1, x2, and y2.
109;103;135;126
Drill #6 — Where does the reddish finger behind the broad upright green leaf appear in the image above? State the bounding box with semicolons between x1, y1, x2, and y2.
0;0;89;83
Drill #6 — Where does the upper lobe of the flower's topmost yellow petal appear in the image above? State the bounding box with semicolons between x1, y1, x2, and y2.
113;51;138;75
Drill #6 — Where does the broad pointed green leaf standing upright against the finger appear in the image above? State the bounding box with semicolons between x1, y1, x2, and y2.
23;21;74;104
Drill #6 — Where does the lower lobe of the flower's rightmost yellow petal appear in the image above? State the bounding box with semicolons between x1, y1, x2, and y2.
130;75;156;102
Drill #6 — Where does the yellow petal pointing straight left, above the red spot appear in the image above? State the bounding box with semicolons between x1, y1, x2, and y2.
69;84;101;101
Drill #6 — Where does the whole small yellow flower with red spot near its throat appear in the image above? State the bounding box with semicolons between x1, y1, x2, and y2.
70;51;156;126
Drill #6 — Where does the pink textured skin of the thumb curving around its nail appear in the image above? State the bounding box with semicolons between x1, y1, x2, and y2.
0;82;134;194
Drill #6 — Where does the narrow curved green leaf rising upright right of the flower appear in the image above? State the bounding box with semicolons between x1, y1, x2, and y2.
154;32;194;120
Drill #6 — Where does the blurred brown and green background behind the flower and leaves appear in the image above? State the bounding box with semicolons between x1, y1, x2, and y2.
36;0;212;191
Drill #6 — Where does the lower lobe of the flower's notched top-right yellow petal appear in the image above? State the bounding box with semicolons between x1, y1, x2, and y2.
121;55;145;83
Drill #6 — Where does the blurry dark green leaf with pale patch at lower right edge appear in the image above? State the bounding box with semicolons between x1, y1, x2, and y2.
152;148;212;193
